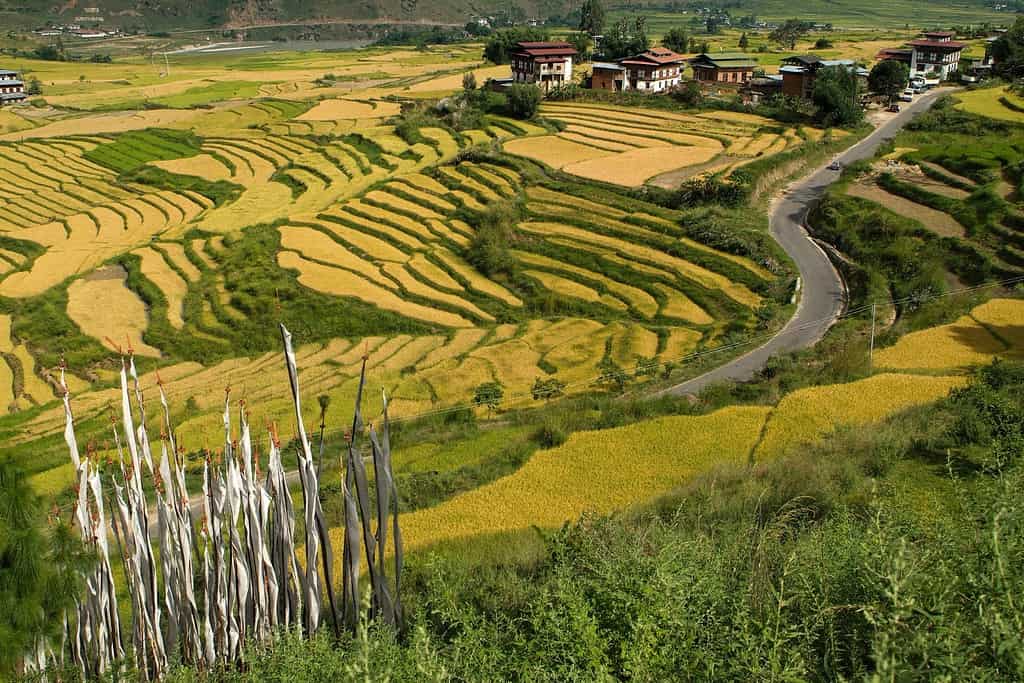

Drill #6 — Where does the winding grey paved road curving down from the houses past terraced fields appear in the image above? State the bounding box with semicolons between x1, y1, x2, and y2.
659;88;952;396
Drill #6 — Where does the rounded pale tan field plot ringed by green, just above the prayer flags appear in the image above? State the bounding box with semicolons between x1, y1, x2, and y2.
68;265;160;356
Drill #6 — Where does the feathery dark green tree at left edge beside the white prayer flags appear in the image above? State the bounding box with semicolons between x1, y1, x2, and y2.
0;463;90;679
